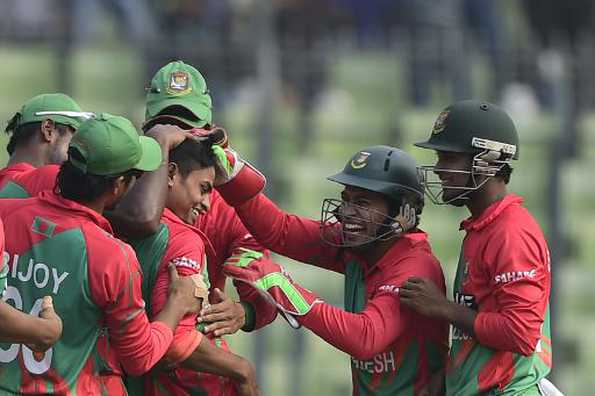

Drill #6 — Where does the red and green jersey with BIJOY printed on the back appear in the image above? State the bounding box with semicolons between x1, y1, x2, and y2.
0;191;173;395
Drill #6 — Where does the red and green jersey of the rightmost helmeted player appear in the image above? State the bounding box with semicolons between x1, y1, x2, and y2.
446;194;552;396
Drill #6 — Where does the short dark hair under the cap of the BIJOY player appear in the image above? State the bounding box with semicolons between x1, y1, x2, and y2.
54;150;142;203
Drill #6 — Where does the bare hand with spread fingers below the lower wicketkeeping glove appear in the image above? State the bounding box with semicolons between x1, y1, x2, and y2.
197;289;246;337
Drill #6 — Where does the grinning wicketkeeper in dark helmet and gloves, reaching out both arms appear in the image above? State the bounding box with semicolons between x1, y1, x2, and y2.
218;146;447;395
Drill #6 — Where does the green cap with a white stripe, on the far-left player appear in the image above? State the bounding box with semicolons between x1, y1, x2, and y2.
6;93;94;132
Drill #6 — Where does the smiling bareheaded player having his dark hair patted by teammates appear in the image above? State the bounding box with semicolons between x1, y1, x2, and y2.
127;139;258;396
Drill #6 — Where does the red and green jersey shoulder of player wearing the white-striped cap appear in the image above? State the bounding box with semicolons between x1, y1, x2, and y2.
0;162;60;198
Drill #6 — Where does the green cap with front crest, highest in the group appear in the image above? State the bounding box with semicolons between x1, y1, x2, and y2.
145;61;213;128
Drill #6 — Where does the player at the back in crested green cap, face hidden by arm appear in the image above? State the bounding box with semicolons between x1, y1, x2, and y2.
141;61;276;336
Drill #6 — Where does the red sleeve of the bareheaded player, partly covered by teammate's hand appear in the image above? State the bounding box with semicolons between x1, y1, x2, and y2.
151;226;208;364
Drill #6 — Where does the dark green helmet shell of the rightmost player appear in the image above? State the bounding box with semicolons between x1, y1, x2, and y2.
415;100;519;159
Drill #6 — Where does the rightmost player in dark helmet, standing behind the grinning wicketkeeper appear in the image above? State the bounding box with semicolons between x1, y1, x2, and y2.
400;100;552;395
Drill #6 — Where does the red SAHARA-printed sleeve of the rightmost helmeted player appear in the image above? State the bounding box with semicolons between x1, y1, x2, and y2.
474;226;551;356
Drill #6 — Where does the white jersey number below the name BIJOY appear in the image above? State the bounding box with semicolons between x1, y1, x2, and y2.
0;286;53;374
